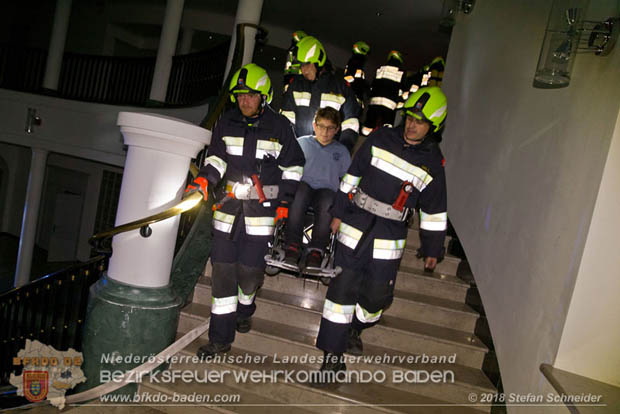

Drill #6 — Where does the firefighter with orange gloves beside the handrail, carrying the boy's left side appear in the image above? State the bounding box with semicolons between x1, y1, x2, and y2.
186;63;305;356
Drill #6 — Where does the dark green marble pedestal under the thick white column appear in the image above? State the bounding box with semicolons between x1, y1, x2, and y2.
80;275;181;395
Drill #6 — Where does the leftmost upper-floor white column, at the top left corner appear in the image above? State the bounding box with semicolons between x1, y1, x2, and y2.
43;0;71;90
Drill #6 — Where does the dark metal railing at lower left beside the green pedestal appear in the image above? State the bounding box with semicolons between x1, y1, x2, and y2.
0;256;107;383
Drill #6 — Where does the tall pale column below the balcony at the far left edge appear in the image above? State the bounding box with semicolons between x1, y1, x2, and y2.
14;148;48;287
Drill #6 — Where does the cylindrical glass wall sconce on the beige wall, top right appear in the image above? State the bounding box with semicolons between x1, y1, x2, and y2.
533;0;620;89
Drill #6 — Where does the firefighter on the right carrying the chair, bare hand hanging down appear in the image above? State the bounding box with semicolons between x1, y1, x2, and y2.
316;87;447;371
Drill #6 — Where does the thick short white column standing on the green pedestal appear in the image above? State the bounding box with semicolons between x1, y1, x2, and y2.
108;112;211;287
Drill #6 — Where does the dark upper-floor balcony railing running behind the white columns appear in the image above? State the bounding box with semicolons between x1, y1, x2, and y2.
0;44;228;106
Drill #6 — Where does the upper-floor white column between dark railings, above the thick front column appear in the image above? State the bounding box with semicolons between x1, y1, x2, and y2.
149;0;185;102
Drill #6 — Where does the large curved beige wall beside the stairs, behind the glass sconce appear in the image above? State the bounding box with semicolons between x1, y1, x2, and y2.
442;0;620;413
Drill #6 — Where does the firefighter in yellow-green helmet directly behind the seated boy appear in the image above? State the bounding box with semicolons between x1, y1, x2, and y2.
281;36;360;151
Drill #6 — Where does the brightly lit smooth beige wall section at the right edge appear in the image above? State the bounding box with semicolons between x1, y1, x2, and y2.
555;108;620;386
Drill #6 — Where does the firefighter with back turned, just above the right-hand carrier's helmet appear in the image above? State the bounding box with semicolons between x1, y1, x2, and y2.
362;50;403;136
